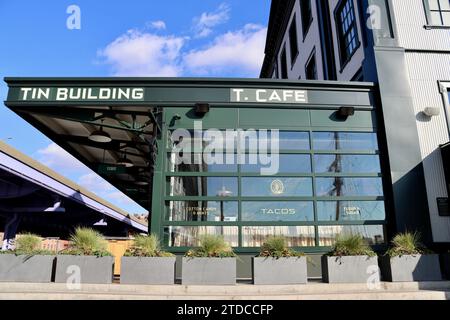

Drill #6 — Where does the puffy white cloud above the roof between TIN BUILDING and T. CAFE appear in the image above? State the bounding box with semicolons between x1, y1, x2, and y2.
98;29;186;77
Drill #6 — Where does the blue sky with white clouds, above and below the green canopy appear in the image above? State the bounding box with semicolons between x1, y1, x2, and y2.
0;0;270;213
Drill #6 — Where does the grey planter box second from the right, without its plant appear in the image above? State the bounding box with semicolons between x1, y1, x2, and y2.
322;256;380;283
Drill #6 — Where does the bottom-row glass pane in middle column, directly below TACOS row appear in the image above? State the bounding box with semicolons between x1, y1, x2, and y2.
242;226;315;247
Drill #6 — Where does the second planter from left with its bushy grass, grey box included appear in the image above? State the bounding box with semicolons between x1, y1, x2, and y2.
55;228;114;284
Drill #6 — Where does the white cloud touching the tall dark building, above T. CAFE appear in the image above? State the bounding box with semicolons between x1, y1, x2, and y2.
184;24;267;77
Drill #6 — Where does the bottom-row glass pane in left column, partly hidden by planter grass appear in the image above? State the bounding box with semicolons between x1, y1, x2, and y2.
164;226;239;247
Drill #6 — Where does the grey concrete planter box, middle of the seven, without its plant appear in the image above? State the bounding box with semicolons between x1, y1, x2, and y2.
181;257;236;285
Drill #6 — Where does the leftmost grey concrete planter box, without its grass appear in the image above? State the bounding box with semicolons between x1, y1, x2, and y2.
0;254;55;283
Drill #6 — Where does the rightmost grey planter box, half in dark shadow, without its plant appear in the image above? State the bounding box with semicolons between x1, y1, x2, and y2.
380;254;442;282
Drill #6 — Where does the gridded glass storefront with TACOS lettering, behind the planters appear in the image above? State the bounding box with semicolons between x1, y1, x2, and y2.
162;110;386;248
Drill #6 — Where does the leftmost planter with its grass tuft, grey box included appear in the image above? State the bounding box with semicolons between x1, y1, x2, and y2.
0;234;55;283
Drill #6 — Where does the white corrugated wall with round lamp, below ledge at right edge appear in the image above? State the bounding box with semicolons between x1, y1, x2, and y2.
406;53;450;242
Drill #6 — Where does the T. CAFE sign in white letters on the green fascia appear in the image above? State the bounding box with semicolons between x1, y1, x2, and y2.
230;88;308;104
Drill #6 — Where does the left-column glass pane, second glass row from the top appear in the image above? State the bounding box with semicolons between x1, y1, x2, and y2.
169;152;237;172
